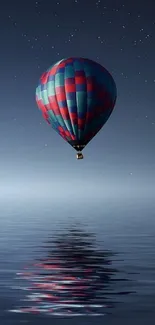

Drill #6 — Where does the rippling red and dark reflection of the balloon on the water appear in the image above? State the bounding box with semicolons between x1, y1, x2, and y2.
9;227;133;316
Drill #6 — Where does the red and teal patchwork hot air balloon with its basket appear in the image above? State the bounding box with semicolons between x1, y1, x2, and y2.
36;57;117;159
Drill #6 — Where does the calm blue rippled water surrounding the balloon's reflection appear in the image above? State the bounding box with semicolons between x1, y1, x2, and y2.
0;199;155;325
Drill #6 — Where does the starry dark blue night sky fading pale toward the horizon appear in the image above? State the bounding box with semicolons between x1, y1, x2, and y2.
0;0;155;199
